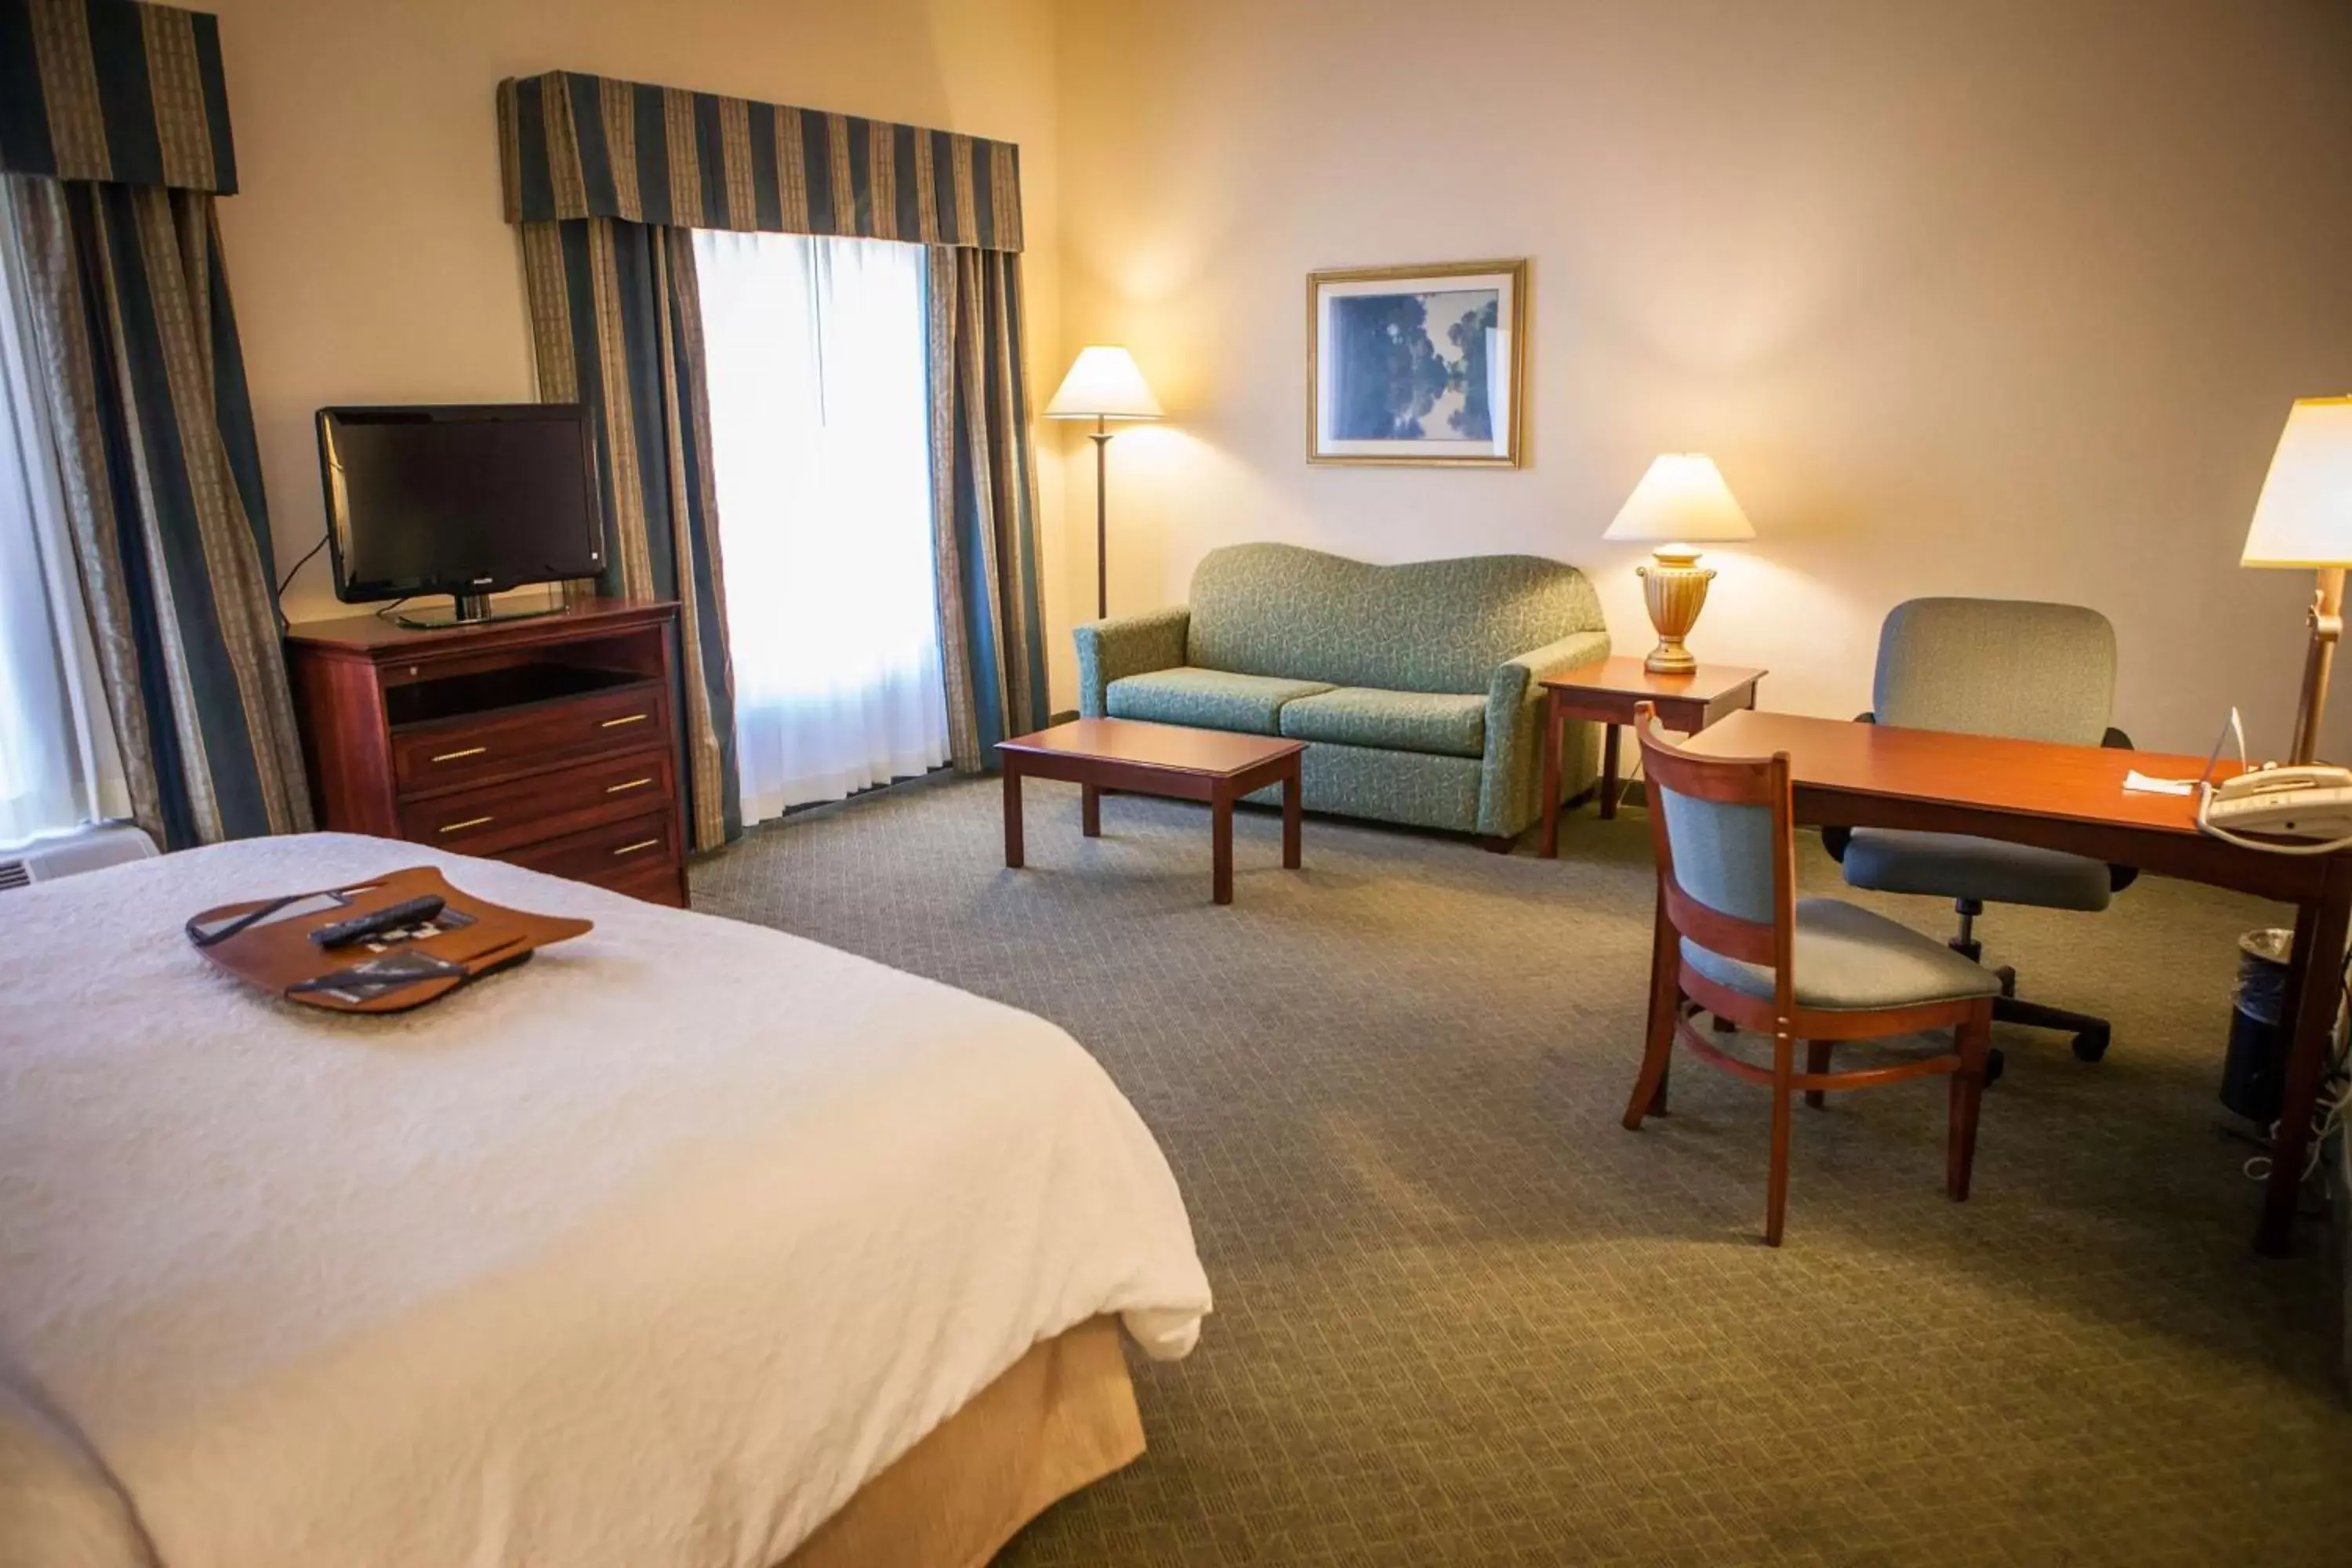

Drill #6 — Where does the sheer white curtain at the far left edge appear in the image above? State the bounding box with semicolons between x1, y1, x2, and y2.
0;214;132;844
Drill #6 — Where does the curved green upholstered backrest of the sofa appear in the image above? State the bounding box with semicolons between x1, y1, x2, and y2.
1185;546;1606;694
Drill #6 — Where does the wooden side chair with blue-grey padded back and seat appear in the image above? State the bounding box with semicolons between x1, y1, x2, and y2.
1625;703;2002;1246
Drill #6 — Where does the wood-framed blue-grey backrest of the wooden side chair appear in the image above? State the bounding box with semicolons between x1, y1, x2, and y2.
1635;703;1797;1015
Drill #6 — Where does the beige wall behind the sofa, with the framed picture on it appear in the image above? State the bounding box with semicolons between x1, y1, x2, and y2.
1058;0;2352;753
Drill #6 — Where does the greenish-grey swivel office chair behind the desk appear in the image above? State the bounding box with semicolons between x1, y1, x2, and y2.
1820;600;2138;1081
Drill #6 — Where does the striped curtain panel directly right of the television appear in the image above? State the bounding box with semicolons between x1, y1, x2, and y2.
522;219;743;848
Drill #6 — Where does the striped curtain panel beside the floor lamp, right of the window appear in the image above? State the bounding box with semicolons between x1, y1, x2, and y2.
931;247;1049;774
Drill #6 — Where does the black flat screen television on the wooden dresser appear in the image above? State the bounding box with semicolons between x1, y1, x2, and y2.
318;402;604;623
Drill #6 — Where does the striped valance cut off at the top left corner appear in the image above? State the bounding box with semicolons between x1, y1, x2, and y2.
0;0;238;195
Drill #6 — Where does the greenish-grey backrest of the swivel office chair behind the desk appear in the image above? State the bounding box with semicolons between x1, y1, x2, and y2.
1870;600;2114;746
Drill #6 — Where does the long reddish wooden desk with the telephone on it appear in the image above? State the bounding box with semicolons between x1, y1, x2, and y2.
1684;713;2352;1255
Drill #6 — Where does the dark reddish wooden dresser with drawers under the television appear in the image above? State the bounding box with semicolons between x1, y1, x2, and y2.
287;600;687;907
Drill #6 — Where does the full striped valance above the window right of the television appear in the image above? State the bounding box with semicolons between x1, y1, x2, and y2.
499;71;1021;252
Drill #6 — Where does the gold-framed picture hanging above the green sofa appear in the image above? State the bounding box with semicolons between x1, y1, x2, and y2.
1308;259;1526;468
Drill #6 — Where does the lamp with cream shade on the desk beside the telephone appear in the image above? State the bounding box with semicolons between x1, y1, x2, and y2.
2237;397;2352;762
